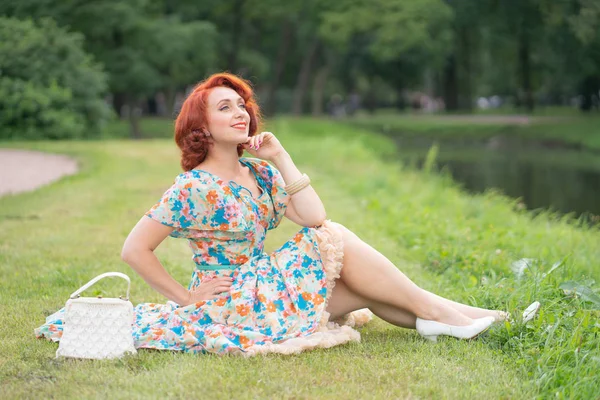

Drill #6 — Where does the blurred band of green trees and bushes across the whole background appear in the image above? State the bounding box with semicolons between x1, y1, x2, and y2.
0;0;600;138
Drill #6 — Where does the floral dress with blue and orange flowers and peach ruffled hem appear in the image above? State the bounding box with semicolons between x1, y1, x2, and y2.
35;158;371;356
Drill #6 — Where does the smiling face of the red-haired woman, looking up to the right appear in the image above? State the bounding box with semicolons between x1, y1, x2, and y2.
207;87;250;144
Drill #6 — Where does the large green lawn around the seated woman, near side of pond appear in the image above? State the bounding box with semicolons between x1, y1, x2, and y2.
0;119;600;399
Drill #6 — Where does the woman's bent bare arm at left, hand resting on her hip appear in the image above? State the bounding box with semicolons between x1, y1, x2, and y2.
121;216;231;306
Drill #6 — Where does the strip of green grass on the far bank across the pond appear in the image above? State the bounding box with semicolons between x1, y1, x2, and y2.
348;111;600;152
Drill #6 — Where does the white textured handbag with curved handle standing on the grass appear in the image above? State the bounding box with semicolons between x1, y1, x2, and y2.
56;272;136;359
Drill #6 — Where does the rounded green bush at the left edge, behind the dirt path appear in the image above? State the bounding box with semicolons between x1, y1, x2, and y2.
0;18;111;140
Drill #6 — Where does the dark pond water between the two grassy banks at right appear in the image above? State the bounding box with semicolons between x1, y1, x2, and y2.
394;135;600;222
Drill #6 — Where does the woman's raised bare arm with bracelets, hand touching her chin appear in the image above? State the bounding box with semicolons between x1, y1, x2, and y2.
244;132;327;227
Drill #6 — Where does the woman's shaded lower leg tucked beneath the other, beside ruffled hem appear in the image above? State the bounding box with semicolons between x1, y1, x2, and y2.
327;279;417;329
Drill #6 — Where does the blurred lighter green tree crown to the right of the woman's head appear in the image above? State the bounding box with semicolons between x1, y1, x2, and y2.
320;0;452;111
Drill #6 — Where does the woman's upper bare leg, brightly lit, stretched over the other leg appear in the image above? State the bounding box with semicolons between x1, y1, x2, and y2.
335;224;496;325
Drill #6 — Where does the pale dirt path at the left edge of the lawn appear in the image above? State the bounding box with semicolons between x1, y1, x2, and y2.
0;149;78;196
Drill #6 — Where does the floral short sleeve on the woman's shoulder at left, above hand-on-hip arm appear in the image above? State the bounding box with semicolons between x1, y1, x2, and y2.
146;179;206;237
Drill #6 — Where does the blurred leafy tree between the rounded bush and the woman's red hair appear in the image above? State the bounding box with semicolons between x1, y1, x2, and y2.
0;0;216;138
